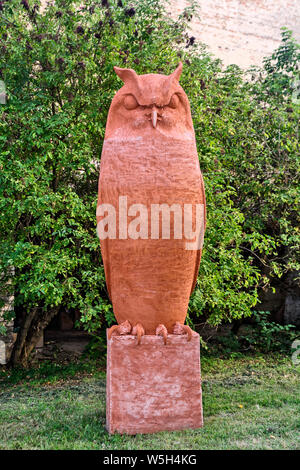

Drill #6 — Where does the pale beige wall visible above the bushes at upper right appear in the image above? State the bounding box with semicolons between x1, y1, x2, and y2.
171;0;300;68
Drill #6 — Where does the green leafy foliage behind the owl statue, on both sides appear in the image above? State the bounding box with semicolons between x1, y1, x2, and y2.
0;0;299;364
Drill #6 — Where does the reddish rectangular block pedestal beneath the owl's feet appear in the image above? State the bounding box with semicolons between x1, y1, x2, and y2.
106;333;203;434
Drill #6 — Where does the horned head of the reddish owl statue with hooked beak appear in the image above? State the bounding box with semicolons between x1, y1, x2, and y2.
106;62;194;138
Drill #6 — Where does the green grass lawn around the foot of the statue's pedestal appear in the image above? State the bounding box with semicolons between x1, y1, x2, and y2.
0;355;300;450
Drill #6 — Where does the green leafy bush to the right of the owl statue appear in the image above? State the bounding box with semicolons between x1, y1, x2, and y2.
186;30;300;324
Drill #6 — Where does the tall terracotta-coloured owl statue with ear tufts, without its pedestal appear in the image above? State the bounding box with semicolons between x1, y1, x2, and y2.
97;63;205;343
